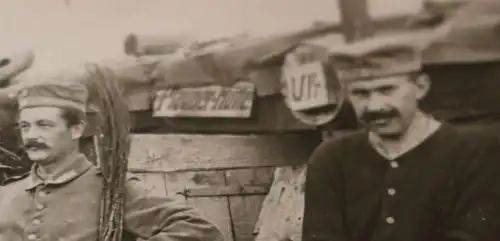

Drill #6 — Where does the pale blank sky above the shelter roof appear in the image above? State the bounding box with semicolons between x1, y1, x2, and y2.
0;0;422;75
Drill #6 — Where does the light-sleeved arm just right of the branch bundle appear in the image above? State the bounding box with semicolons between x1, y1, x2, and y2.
125;182;223;241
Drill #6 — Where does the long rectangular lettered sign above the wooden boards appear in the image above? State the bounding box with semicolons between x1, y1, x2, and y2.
153;83;255;118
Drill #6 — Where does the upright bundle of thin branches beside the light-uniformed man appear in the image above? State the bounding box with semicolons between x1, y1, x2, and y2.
84;64;130;241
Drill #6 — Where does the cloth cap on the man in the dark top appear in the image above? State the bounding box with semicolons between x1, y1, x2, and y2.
329;33;427;82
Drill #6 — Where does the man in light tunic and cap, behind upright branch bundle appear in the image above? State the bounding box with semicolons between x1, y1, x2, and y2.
0;82;223;241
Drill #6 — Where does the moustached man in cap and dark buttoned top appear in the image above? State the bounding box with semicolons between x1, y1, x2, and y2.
303;35;500;241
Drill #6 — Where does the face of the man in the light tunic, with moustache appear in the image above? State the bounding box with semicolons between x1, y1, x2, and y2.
18;107;79;163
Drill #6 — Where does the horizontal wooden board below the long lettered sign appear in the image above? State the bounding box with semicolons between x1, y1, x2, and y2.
129;133;319;172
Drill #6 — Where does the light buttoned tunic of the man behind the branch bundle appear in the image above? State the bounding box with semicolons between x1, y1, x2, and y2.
0;155;223;241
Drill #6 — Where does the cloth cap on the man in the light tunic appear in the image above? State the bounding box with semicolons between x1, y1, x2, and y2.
16;82;88;112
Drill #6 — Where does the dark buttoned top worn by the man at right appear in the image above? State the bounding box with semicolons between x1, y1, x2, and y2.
303;124;500;241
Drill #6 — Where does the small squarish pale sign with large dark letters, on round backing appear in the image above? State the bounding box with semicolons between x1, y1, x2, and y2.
283;61;330;111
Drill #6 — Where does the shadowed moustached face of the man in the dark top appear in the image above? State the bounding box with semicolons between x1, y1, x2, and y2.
347;75;430;138
